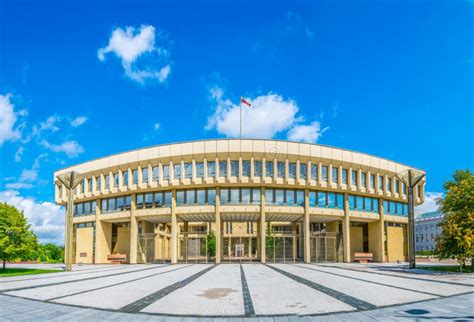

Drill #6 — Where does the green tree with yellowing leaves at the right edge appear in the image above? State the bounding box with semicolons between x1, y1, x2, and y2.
436;170;474;272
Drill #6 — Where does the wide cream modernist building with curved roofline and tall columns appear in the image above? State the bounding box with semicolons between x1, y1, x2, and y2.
55;139;425;264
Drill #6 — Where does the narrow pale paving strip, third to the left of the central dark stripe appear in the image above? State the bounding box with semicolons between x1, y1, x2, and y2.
6;265;181;300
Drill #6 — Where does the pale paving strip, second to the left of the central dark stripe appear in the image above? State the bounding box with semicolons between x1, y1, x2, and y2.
54;264;210;310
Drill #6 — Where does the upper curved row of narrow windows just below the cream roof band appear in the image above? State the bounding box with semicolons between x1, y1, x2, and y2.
72;160;406;193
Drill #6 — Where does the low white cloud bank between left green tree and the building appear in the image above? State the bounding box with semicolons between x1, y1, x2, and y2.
0;190;64;245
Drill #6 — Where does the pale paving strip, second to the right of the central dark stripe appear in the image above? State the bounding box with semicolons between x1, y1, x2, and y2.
271;264;435;306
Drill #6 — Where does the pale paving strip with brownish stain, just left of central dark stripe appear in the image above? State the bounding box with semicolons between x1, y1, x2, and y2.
141;264;244;316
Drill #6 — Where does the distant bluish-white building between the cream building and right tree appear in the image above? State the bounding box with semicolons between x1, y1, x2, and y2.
415;211;443;252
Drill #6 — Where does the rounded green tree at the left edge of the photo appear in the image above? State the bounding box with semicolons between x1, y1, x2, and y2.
0;203;38;270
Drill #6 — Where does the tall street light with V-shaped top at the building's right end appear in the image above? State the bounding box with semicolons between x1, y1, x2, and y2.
397;169;425;269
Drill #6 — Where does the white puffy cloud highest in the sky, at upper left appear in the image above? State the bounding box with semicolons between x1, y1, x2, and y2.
97;25;171;84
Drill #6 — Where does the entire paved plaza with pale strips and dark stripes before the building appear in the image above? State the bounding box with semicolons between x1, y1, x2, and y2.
0;263;474;321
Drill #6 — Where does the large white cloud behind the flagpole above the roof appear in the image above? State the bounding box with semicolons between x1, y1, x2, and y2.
206;86;322;142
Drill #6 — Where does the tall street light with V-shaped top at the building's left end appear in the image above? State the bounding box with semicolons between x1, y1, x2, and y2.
57;171;84;272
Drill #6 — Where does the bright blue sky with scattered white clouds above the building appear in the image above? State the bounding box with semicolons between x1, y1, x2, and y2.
0;0;474;242
